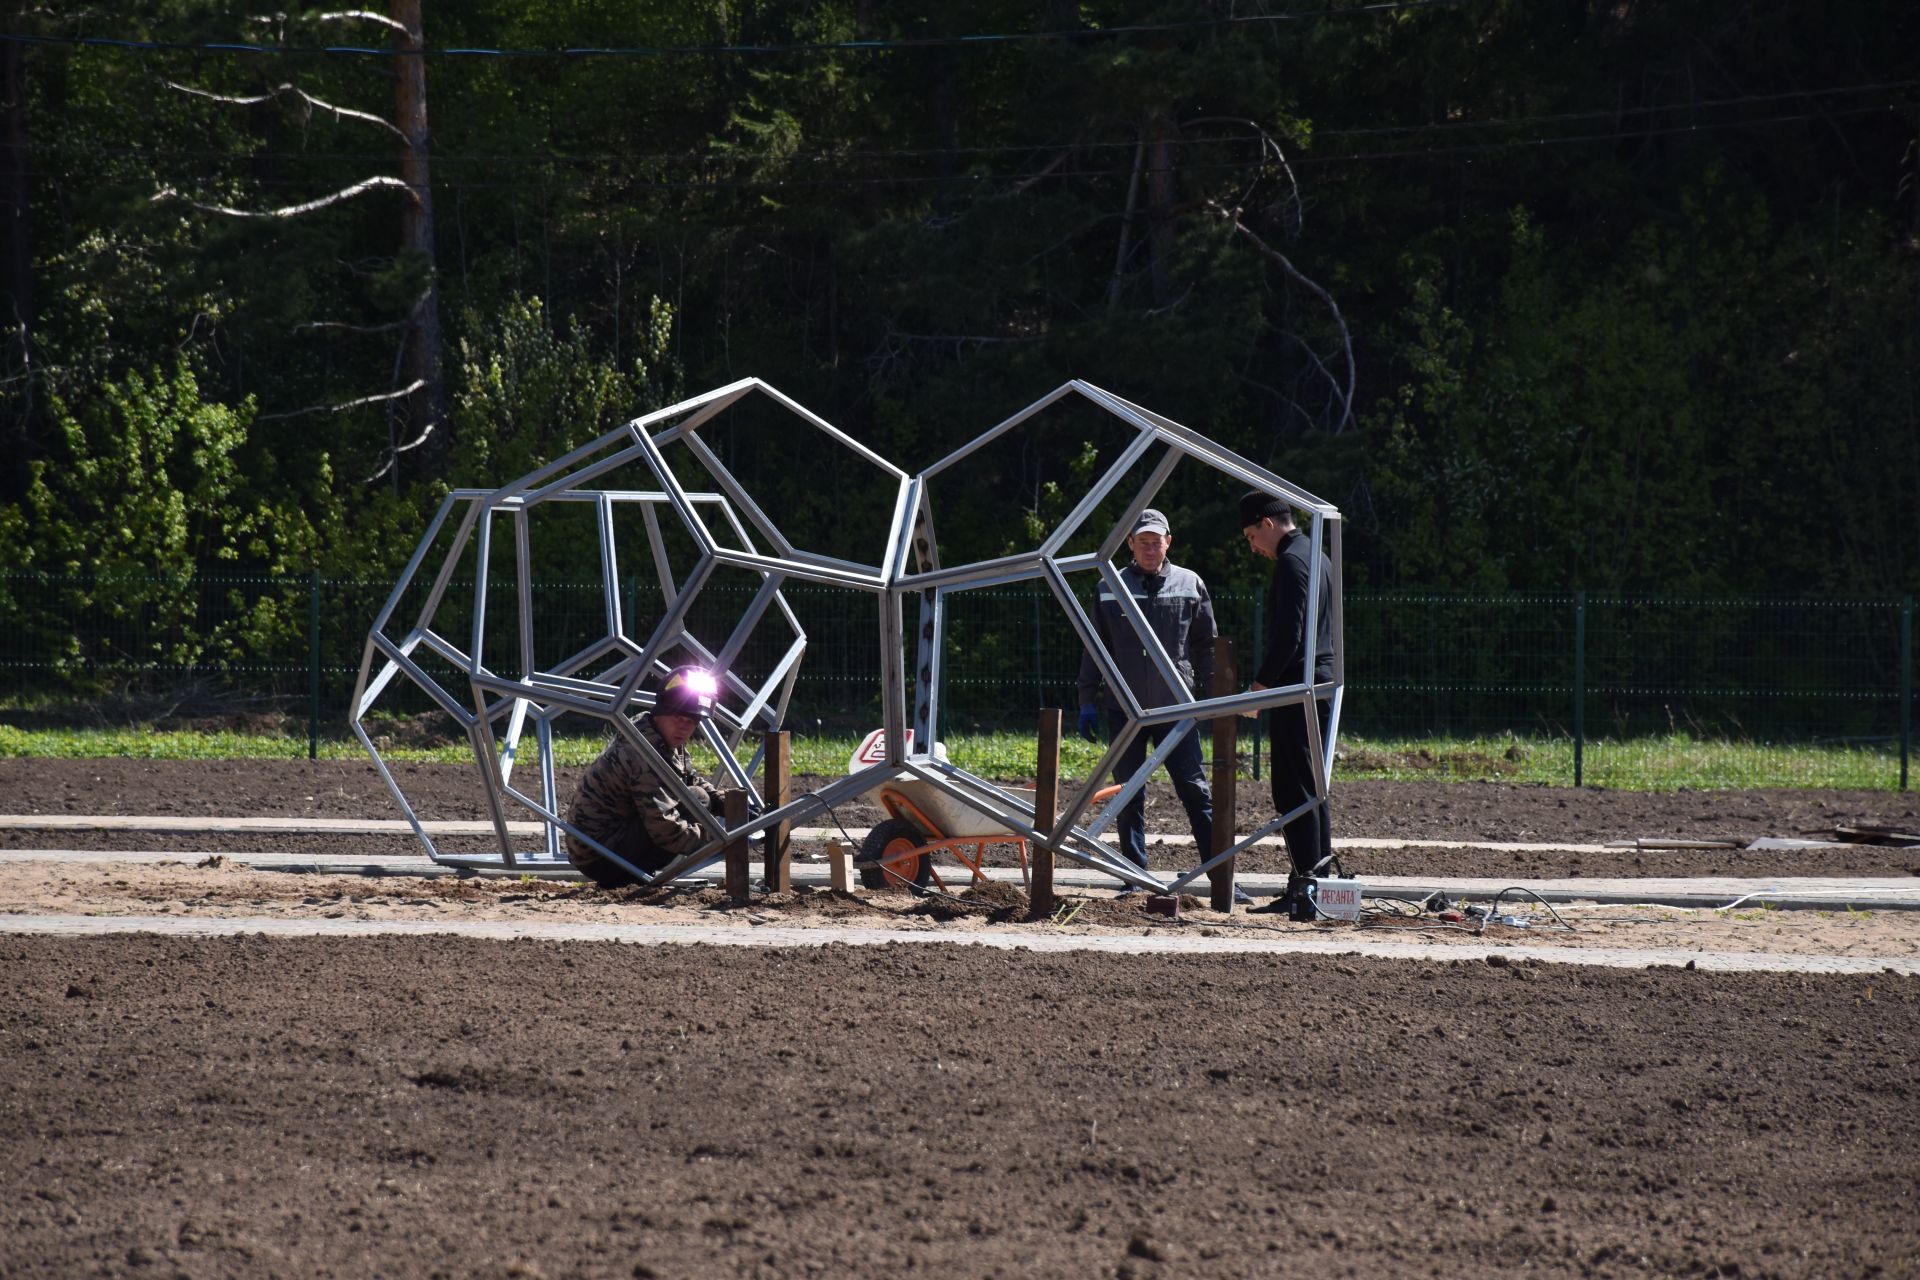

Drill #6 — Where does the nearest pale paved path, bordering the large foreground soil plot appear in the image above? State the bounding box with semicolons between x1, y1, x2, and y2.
0;915;1920;977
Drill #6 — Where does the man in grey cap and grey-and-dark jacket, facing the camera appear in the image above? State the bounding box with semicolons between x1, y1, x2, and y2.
1079;507;1215;894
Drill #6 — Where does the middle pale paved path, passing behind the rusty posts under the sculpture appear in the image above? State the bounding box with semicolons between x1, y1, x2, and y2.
0;848;1920;912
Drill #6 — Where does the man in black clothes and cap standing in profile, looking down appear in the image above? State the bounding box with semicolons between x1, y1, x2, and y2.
1240;489;1332;912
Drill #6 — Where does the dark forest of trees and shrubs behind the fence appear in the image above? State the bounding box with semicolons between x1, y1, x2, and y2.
0;0;1920;690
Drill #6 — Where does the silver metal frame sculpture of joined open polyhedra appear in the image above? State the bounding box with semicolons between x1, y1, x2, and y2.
351;378;1344;892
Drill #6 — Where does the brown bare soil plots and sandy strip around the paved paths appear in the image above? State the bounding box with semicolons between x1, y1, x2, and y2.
0;760;1920;1280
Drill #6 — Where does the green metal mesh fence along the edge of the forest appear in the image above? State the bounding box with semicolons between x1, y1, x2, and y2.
0;572;1914;789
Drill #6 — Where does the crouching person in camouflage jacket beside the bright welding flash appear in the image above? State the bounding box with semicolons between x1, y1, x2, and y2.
566;666;720;889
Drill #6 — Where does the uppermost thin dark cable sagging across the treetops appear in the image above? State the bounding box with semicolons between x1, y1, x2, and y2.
0;0;1486;58
